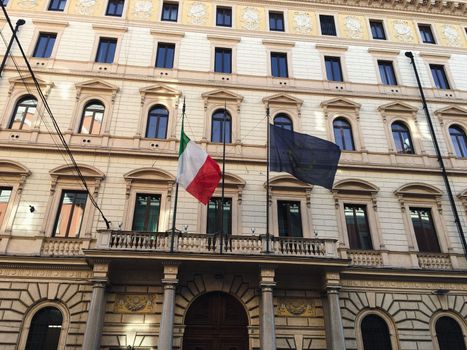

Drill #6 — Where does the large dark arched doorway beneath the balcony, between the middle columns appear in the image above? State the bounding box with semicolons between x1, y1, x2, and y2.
183;292;248;350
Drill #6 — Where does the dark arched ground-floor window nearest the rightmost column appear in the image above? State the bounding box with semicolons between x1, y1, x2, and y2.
360;314;392;350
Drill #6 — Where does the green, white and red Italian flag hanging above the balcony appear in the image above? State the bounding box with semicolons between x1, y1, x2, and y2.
177;129;221;205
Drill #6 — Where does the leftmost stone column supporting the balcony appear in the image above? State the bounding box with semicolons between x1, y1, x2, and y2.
83;263;109;350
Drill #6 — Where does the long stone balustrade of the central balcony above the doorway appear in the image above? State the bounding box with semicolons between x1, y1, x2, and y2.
96;231;338;258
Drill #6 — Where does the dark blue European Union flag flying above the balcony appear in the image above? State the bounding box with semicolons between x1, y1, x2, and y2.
269;124;341;190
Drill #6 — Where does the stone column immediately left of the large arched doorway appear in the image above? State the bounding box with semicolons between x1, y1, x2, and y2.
157;263;178;350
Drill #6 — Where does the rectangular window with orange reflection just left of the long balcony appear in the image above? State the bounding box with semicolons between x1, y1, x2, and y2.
53;191;88;237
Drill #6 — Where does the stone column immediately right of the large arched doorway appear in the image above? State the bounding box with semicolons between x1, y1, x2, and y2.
260;267;276;350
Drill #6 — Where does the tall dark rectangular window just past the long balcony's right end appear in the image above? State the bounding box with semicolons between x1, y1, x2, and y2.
344;204;373;250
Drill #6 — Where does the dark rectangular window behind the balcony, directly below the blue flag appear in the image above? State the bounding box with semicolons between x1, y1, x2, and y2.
277;201;303;237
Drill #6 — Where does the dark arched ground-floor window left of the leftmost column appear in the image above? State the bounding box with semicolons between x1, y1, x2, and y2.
26;307;63;350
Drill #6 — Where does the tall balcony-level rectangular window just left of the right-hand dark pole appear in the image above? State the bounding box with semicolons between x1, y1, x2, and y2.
410;208;441;253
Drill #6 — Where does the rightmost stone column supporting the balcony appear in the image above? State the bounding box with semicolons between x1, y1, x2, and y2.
324;273;345;350
